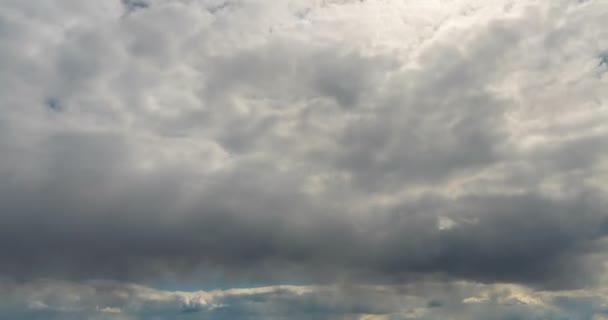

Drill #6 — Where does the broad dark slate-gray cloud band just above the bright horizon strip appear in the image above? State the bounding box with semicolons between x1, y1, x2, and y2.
0;144;606;286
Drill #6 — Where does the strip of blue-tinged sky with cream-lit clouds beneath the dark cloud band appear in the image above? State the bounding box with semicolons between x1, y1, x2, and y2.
5;280;608;320
